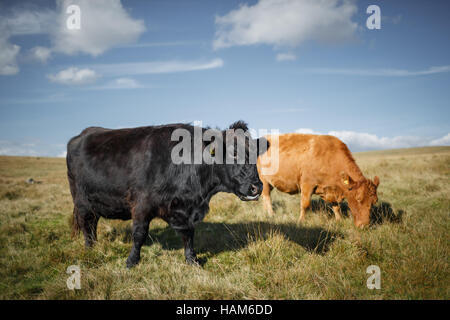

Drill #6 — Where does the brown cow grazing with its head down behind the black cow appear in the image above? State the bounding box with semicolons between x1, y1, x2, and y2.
257;133;380;227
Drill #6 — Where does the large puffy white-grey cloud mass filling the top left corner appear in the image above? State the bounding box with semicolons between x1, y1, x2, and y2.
0;0;145;75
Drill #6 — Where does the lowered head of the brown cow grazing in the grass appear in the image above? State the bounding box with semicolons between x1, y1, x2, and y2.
341;172;380;228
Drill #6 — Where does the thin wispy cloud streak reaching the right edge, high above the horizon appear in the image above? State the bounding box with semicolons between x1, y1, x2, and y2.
308;66;450;77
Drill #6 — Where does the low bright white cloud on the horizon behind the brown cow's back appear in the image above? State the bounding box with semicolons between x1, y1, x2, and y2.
295;128;450;151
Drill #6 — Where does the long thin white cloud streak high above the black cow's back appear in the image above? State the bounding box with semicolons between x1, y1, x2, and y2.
91;58;223;76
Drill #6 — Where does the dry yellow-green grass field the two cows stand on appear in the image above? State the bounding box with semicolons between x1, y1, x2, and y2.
0;147;450;299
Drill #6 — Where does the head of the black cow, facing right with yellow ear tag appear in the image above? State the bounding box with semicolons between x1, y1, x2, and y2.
212;121;267;201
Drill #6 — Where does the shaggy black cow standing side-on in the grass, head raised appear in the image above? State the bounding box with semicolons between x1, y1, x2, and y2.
67;121;262;267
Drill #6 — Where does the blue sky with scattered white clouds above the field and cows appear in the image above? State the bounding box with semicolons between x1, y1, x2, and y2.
0;0;450;156
